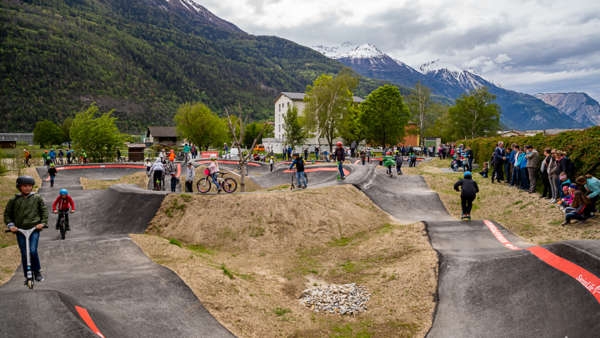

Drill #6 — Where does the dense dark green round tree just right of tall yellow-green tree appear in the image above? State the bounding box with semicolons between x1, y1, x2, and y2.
360;85;410;147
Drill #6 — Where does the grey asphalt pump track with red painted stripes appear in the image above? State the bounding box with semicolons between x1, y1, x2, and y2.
0;164;600;337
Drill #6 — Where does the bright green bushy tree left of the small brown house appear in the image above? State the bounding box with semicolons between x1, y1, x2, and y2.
71;104;122;162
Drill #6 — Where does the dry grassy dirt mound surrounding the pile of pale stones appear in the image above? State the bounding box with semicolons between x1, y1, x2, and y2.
139;185;437;337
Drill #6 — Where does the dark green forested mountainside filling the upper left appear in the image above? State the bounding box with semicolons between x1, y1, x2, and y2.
0;0;374;132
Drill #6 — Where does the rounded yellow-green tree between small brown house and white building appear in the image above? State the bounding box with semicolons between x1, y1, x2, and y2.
174;103;227;148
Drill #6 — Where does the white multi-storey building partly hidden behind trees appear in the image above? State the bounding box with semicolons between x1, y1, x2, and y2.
263;92;364;153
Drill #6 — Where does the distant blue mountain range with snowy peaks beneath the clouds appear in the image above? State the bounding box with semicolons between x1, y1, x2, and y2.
313;42;600;130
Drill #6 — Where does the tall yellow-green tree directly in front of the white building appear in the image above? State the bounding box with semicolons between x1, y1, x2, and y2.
304;68;358;151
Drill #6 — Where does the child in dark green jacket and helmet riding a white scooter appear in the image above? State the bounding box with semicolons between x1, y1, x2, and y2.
4;176;48;282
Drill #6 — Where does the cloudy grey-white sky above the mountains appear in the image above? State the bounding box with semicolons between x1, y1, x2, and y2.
195;0;600;101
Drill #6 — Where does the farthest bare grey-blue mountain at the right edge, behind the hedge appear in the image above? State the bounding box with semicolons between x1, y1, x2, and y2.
535;93;600;126
